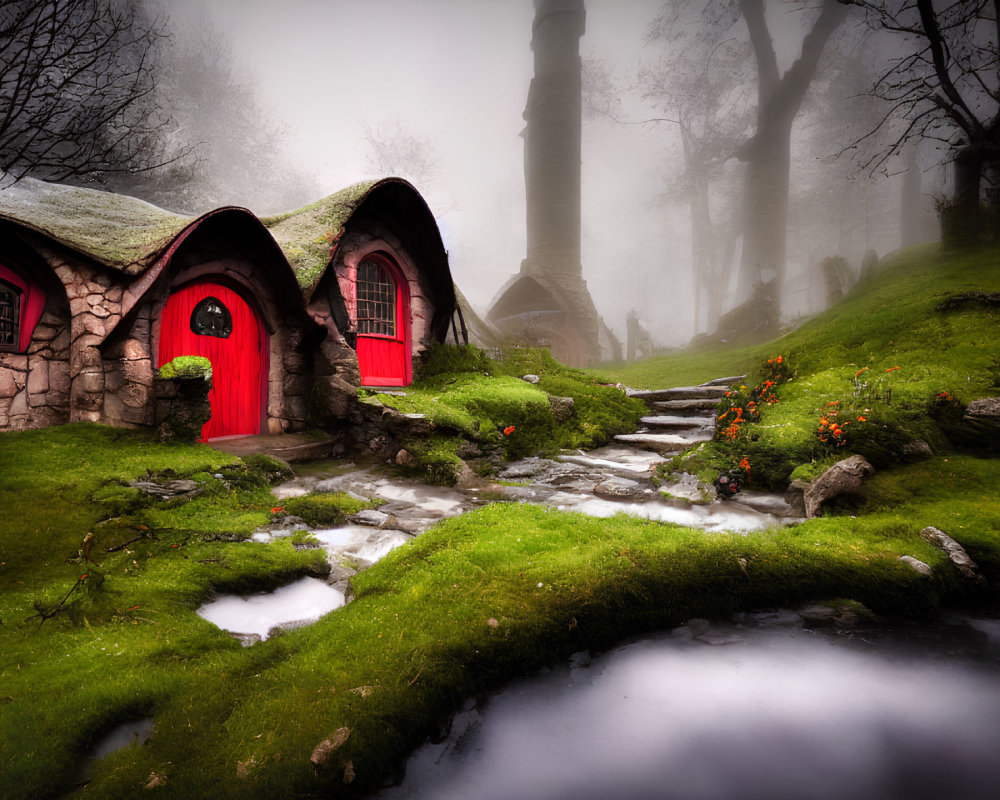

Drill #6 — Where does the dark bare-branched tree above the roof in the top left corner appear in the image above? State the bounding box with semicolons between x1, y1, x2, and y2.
0;0;187;183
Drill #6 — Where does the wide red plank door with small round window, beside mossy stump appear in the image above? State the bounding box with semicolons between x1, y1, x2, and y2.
157;281;268;440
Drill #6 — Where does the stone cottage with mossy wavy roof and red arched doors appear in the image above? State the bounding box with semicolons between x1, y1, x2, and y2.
0;178;464;439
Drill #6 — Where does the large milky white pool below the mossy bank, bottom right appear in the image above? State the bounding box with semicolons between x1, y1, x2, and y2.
376;626;1000;800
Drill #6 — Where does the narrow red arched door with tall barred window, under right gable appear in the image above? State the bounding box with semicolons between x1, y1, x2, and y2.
357;256;413;386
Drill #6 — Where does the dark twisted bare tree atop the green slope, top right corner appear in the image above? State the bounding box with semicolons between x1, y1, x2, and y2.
844;0;1000;242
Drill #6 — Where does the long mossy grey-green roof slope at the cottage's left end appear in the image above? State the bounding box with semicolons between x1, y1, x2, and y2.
0;178;194;274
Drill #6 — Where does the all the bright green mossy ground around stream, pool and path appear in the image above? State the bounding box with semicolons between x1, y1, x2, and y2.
0;248;1000;800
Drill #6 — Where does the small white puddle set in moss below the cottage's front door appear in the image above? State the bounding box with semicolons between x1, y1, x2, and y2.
197;578;344;644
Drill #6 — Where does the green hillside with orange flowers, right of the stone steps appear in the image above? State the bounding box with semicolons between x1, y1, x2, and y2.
603;245;1000;489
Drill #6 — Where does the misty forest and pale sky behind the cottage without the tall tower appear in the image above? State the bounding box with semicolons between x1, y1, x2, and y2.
0;0;988;347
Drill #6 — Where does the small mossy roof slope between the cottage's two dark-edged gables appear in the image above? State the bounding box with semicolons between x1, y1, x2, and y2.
261;180;385;288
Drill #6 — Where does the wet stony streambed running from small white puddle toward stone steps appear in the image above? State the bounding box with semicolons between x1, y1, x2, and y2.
198;444;801;645
